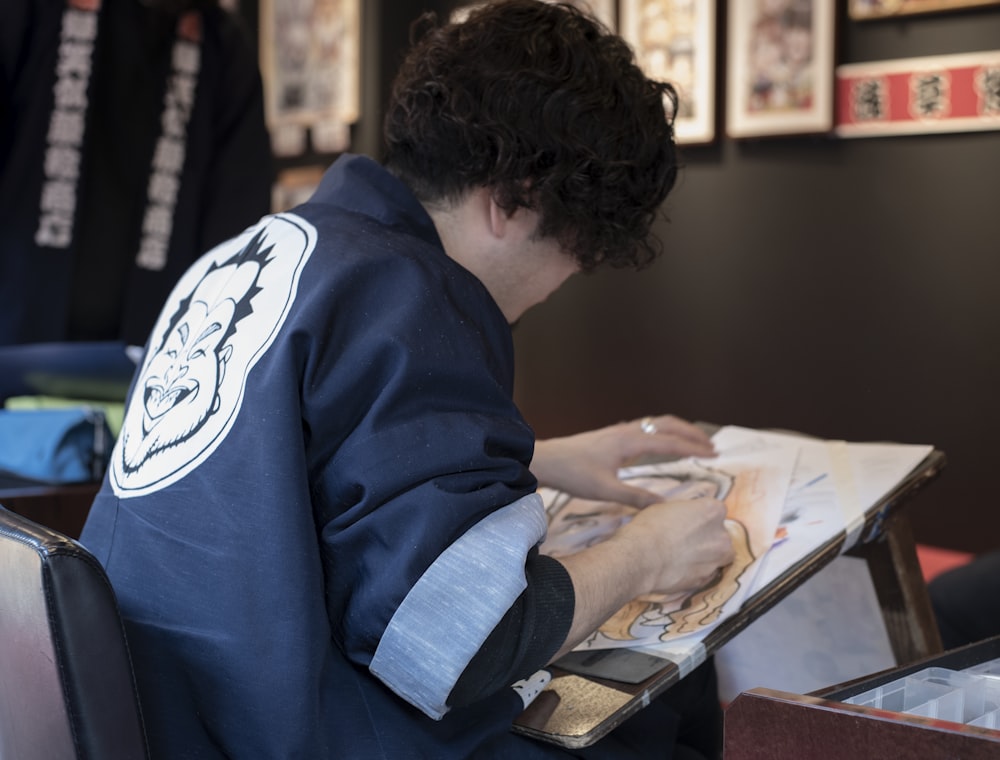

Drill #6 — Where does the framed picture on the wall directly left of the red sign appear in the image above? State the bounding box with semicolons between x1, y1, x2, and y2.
726;0;836;138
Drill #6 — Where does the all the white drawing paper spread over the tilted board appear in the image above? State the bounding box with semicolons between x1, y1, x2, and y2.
541;426;933;667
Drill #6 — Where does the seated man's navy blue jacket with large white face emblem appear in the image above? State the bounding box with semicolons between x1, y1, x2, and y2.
82;157;576;758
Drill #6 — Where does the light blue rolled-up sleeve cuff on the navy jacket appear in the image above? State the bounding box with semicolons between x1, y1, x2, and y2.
369;494;547;720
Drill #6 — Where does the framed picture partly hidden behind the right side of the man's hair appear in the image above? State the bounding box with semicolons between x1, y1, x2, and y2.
620;0;716;143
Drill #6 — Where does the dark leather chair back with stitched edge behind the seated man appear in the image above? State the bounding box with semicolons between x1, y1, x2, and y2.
0;506;148;760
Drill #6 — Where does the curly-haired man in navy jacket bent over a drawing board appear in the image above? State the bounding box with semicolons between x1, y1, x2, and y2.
82;0;732;758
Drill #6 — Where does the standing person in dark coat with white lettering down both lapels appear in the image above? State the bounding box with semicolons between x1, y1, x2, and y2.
0;0;273;345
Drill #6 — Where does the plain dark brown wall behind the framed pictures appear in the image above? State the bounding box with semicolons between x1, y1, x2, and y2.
245;0;1000;551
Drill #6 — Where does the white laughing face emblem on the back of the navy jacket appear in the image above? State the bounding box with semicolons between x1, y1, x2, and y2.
110;215;316;498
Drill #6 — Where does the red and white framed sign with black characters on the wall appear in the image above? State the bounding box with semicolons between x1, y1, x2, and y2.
835;51;1000;137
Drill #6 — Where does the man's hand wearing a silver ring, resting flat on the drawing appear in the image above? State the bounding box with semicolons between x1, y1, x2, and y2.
531;415;715;507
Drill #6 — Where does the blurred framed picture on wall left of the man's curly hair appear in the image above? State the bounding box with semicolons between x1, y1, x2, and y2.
260;0;361;156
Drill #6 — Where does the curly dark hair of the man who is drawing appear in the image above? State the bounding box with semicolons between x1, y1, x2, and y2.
385;0;677;271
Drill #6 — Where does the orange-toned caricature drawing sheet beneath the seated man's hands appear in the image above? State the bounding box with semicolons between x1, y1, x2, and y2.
541;448;793;649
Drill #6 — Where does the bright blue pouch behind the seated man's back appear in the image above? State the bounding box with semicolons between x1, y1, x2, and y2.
0;406;112;483
